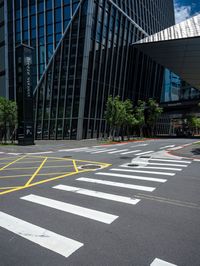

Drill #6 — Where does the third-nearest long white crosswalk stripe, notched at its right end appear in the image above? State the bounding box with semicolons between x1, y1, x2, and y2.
53;185;140;205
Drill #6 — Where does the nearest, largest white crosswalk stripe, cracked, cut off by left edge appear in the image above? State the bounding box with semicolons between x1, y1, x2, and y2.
0;212;83;258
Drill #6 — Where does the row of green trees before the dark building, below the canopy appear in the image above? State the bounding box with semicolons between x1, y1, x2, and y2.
105;96;163;140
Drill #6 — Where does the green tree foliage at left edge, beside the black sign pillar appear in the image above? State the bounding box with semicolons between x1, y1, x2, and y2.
0;97;17;142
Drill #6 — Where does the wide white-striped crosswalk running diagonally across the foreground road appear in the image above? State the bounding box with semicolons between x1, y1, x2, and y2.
0;157;191;258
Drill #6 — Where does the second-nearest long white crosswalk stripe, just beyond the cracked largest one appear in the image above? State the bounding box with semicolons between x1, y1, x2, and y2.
21;194;118;224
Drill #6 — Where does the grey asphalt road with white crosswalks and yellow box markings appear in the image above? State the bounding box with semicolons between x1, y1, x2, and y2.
0;139;200;266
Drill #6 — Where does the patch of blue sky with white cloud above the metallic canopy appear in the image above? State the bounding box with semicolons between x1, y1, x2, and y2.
174;0;200;23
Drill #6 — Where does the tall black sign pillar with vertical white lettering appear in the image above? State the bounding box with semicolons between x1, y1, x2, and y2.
16;44;34;145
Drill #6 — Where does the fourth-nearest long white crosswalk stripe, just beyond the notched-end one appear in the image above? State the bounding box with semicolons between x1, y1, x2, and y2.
76;177;156;192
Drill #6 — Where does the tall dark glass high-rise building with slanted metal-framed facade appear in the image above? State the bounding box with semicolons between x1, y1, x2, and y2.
0;0;174;139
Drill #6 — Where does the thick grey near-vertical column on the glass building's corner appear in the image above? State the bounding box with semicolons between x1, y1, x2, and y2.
77;1;94;140
